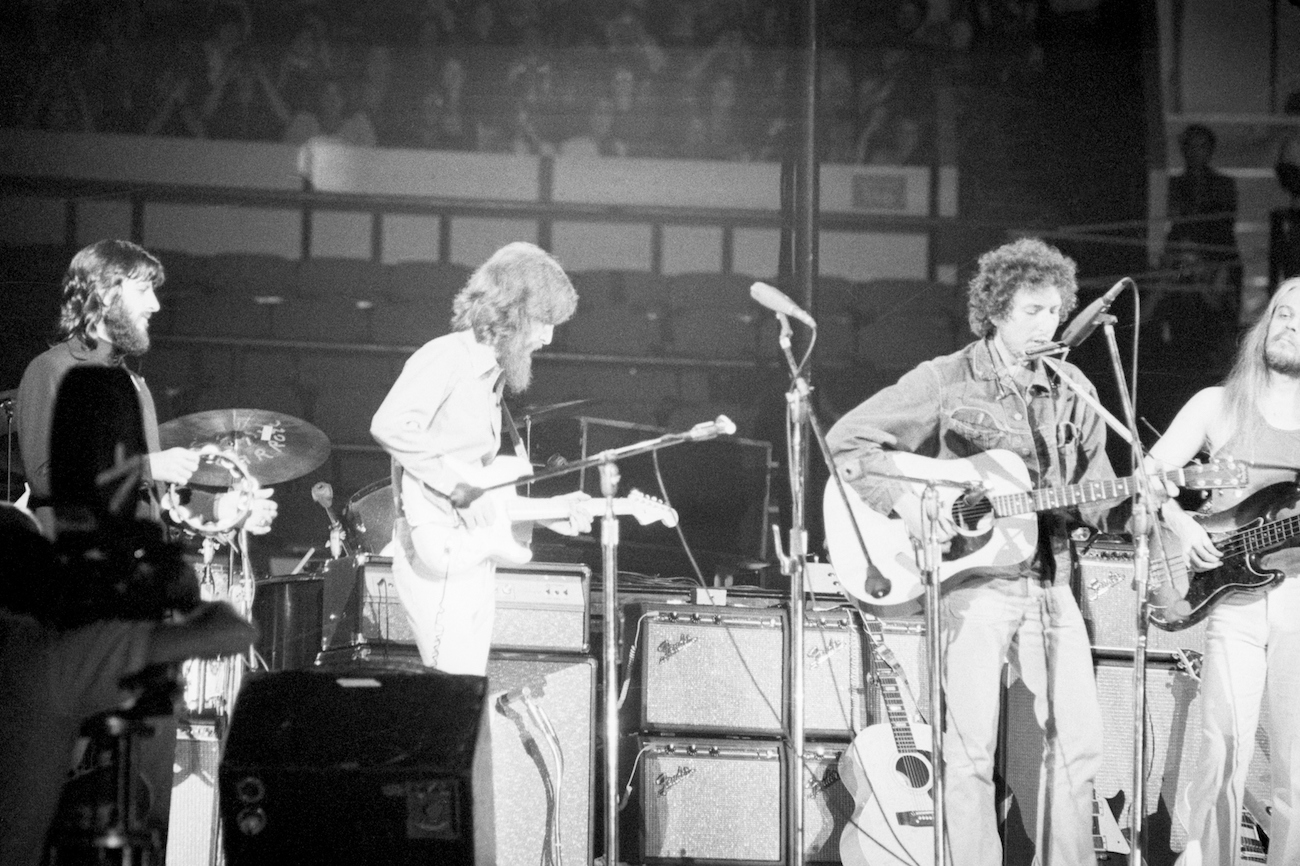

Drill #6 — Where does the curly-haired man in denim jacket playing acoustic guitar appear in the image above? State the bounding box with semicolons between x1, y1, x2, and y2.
827;238;1133;866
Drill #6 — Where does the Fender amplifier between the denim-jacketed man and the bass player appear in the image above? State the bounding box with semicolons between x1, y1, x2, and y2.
1074;534;1205;655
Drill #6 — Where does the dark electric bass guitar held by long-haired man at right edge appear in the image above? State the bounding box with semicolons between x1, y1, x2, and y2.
1151;481;1300;632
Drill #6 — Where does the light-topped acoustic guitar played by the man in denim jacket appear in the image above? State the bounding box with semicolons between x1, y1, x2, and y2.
822;450;1248;606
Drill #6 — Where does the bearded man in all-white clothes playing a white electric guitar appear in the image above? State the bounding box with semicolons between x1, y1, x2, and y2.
371;242;592;676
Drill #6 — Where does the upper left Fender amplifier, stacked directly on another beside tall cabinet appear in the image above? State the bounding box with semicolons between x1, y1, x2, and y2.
623;605;785;736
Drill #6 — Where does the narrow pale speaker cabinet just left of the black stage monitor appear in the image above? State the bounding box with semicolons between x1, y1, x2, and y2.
166;722;224;866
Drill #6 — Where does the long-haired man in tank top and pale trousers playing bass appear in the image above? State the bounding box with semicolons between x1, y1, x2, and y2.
1151;278;1300;866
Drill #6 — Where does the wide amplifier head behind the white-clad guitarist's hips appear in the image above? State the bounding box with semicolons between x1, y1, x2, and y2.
322;554;592;653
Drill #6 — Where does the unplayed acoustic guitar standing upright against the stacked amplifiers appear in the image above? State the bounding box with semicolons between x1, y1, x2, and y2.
840;616;935;866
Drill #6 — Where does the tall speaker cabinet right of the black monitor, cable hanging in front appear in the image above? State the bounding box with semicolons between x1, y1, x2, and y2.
488;653;595;866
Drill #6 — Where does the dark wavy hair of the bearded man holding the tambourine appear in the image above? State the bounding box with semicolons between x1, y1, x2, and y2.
55;241;166;348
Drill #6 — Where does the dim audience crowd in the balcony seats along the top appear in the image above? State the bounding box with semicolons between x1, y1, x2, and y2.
0;0;1055;165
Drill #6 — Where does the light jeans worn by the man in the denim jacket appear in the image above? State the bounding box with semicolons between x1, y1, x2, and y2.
943;577;1102;866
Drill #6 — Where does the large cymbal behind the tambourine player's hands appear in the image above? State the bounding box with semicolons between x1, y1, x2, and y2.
159;408;329;486
